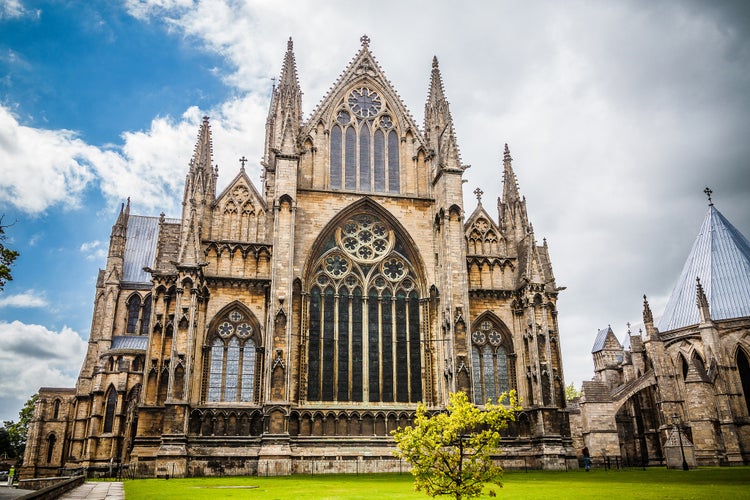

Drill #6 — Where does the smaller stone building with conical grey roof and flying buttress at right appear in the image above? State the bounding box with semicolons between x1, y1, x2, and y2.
571;193;750;467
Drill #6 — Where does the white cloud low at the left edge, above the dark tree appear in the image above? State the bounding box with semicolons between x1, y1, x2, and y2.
0;321;87;418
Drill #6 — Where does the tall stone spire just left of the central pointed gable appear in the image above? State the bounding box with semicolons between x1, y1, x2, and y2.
265;38;302;163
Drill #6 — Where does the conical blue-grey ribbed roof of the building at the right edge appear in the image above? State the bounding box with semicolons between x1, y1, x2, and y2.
657;205;750;332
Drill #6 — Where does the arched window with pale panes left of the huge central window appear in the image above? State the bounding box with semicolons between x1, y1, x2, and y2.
205;309;259;403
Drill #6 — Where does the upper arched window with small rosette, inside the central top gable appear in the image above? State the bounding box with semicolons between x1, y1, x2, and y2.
329;87;401;193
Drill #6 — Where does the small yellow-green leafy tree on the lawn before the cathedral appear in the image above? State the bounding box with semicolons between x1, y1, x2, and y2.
393;391;521;499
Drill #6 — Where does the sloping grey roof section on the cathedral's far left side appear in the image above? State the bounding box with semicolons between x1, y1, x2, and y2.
122;215;179;284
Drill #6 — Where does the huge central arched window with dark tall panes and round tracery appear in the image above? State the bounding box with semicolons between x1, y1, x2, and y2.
307;214;422;403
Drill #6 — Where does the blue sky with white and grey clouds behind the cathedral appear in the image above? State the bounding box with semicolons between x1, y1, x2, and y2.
0;0;750;420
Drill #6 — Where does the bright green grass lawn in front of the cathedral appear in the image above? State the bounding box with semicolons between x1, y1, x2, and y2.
125;467;750;500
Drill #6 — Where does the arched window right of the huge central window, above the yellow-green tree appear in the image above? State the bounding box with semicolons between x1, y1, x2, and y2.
471;317;515;404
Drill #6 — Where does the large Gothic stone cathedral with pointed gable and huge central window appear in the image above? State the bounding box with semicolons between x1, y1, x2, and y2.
23;36;577;477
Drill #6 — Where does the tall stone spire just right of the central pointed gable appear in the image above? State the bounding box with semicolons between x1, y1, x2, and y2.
424;57;464;171
